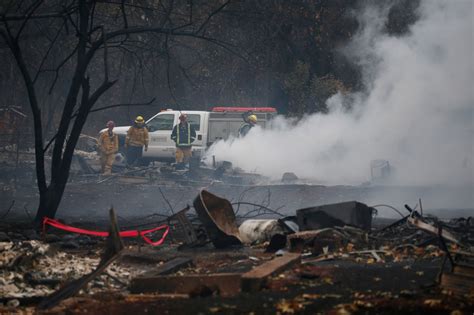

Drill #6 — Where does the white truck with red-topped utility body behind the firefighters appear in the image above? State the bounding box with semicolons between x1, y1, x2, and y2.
109;107;277;162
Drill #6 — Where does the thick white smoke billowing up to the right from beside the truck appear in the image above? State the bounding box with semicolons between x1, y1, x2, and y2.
207;0;474;185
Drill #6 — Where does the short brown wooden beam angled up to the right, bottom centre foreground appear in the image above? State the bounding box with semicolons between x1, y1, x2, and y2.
241;253;301;292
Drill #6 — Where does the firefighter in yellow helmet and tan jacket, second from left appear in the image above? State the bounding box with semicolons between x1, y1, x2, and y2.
125;116;148;167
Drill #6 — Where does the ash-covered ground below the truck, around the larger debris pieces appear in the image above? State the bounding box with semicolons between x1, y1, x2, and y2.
0;162;474;314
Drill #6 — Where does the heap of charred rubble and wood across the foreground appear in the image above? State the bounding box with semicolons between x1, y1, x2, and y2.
0;190;474;314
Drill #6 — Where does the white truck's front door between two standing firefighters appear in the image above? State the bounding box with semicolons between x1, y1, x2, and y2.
143;113;175;160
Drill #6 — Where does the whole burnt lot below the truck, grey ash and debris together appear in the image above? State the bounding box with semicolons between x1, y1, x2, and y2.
0;161;474;314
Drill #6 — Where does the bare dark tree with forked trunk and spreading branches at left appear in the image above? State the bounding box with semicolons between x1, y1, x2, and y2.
0;0;235;222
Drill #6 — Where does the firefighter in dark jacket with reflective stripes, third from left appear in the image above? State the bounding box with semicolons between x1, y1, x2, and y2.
171;114;196;169
